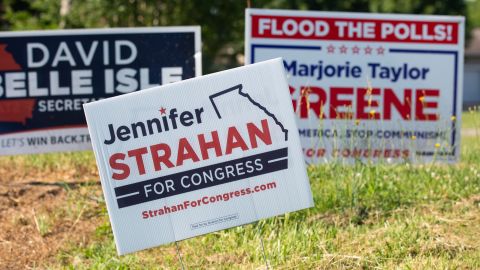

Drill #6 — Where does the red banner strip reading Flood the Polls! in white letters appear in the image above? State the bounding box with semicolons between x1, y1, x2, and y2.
252;15;459;44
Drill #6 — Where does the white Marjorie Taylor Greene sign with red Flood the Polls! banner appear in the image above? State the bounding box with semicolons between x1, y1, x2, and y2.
245;9;464;163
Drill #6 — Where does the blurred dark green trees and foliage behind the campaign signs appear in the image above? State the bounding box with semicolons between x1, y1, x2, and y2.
0;0;480;74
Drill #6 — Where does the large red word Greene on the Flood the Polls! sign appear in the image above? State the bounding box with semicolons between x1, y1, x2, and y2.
290;86;439;121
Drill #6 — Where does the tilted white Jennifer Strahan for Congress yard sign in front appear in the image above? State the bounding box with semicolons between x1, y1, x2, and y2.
84;59;313;254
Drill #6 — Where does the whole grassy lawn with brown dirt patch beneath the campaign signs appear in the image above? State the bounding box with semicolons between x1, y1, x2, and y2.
0;110;480;269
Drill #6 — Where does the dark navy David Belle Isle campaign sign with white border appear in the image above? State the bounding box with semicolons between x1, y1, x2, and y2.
0;26;202;155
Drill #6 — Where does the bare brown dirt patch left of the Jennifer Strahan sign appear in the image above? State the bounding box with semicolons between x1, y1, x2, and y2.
0;163;104;269
